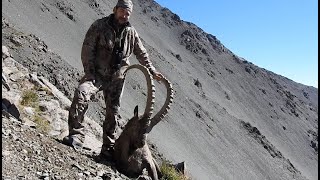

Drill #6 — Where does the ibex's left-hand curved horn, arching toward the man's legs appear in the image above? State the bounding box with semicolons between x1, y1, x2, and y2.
125;64;155;119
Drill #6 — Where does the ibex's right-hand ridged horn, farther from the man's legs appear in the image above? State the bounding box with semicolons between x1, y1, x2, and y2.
147;78;173;133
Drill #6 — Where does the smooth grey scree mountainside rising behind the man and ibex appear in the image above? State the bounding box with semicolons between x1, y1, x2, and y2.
2;0;318;180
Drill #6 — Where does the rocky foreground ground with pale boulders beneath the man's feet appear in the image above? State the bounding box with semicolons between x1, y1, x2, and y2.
2;46;164;180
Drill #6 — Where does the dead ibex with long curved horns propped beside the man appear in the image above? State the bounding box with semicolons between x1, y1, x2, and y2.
114;64;173;180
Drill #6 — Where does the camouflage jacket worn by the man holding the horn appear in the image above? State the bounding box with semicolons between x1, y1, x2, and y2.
81;14;155;77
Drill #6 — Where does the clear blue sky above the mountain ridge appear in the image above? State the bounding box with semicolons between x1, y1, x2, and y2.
156;0;318;88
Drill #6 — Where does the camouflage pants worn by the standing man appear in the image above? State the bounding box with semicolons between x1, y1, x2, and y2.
68;74;124;150
